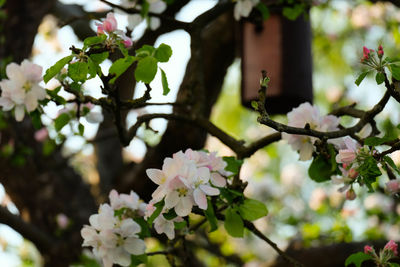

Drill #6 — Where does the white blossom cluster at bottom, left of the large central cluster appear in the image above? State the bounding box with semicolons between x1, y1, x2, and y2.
81;190;146;267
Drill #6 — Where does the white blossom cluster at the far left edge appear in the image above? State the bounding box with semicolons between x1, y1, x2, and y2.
0;60;46;121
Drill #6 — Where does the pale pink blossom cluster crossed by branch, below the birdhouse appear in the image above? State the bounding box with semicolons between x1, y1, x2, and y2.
282;102;339;161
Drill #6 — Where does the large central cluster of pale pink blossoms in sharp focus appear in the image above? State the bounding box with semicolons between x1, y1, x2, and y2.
146;149;230;239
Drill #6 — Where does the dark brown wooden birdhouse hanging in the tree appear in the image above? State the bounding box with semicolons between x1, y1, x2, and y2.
241;12;313;114
